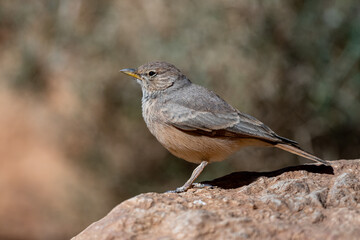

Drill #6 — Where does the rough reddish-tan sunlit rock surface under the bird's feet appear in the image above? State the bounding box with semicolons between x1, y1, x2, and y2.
73;160;360;240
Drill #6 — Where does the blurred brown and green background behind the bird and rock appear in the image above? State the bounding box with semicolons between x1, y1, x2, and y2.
0;0;360;240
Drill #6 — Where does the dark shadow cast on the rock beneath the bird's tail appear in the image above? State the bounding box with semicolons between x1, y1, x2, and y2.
201;165;334;189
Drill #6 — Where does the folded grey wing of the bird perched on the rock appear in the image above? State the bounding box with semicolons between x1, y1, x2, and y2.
162;85;295;143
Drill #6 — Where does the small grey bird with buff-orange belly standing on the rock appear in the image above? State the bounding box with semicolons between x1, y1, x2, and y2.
120;61;329;193
